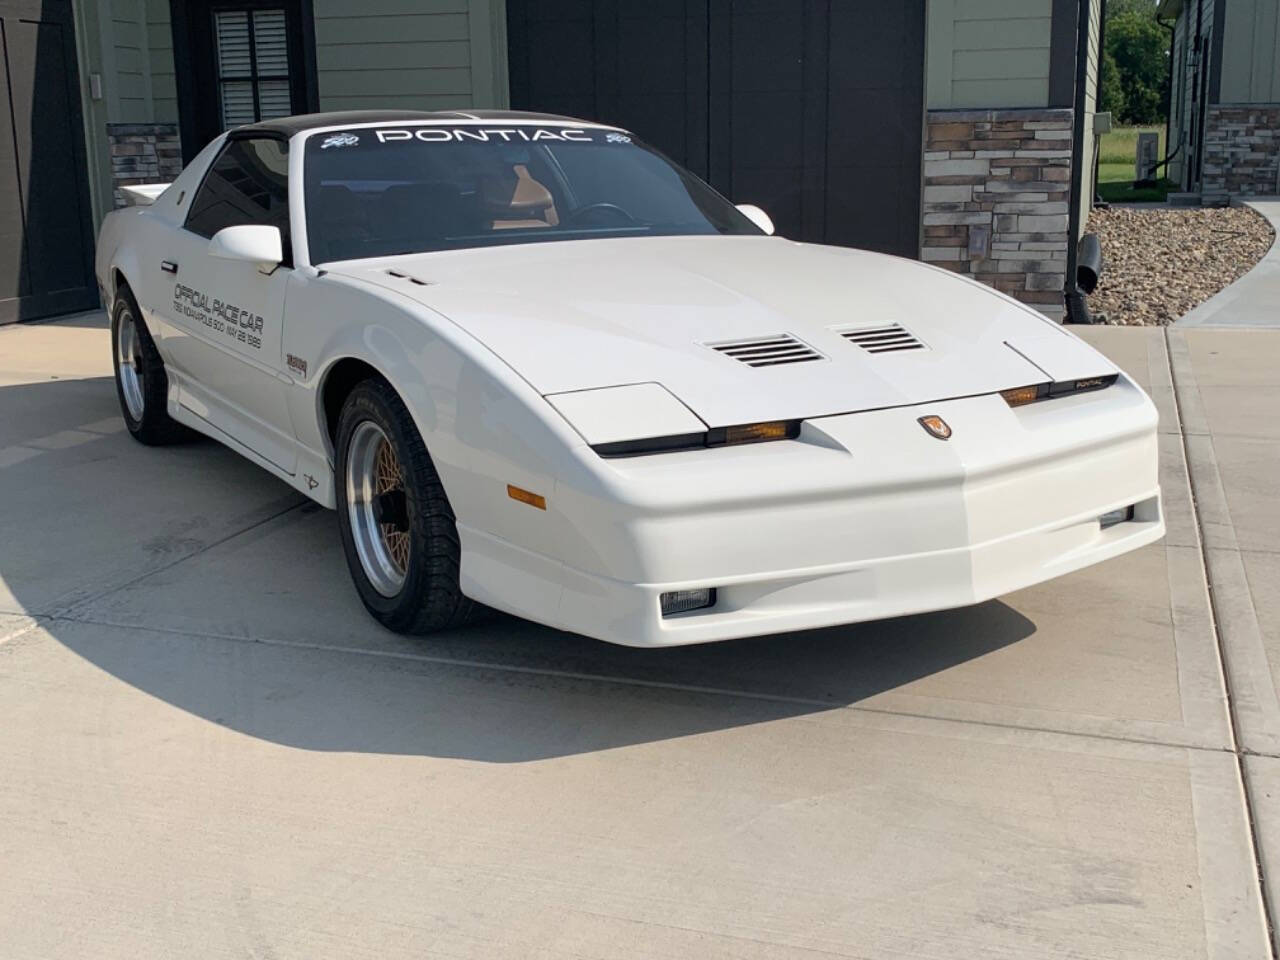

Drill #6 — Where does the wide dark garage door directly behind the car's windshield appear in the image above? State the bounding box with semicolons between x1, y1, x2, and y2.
507;0;924;257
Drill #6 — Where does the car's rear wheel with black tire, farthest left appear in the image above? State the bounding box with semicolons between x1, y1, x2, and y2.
111;287;187;445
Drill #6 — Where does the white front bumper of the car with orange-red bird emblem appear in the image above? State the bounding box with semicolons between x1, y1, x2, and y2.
462;378;1165;646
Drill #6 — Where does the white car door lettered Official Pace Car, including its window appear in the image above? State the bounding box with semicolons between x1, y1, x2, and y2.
161;137;297;474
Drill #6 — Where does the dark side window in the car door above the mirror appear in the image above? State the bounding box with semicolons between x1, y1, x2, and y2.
183;140;293;266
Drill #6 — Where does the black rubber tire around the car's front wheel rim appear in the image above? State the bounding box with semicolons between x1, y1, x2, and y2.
335;379;475;634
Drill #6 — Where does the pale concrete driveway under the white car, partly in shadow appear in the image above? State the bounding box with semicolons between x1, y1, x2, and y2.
0;317;1280;960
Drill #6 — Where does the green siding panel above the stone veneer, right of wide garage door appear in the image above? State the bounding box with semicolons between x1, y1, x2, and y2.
925;0;1053;110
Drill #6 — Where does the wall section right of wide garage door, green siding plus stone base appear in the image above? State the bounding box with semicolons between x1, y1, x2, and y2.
920;0;1102;319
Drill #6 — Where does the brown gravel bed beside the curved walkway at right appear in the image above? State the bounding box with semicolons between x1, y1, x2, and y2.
1088;206;1275;326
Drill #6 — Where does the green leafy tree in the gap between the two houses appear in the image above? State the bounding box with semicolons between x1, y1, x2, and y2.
1101;4;1169;124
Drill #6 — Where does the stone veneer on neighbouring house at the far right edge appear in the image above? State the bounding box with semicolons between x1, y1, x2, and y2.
1201;104;1280;202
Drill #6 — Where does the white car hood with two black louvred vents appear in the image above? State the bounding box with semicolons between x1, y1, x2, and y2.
328;237;1115;426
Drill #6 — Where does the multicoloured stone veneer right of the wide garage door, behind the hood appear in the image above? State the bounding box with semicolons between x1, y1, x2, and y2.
920;109;1074;319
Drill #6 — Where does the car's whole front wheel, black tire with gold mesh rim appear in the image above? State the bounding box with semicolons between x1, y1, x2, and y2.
335;380;474;634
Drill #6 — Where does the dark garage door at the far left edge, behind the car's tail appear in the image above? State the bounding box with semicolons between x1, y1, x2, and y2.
0;0;97;323
